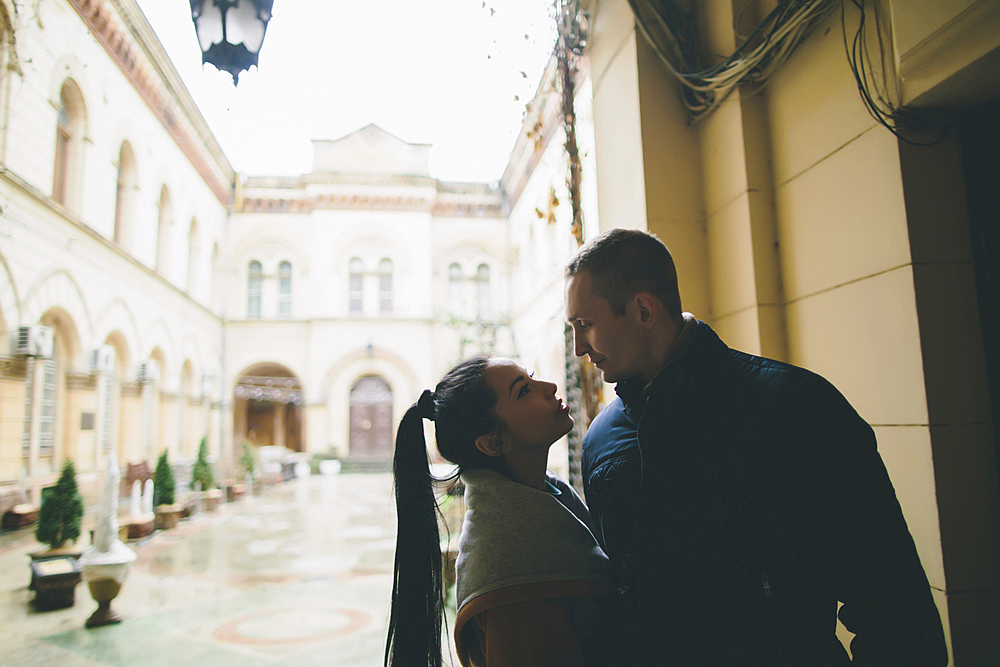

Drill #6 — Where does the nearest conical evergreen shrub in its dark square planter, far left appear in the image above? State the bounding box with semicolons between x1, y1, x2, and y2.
29;459;83;609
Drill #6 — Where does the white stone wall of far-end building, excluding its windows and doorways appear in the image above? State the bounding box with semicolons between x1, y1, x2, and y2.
226;126;509;456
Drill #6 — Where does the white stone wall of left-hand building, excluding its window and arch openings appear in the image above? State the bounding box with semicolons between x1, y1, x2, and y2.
0;0;231;500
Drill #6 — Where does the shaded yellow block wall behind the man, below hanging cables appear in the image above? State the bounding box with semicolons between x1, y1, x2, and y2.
589;0;1000;665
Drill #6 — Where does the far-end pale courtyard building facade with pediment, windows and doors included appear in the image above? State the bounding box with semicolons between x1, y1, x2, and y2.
225;125;511;468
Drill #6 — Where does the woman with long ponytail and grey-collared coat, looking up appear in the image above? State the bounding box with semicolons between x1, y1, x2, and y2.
385;357;608;667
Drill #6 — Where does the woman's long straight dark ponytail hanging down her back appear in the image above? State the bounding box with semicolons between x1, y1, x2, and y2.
384;391;444;667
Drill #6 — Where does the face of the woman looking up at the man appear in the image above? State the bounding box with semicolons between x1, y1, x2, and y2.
486;359;573;448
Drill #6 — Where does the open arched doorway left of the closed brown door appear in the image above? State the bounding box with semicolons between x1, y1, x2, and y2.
233;363;306;456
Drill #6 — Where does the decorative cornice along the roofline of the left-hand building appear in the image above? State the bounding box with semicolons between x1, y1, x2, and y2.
69;0;235;206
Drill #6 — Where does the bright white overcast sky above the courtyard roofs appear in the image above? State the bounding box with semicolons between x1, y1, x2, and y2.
137;0;554;181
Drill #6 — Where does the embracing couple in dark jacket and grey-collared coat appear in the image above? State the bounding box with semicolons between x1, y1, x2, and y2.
386;229;948;667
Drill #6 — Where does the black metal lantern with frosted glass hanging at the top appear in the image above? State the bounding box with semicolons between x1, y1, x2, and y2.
191;0;274;85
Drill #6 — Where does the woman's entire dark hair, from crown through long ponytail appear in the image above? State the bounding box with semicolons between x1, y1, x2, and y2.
384;357;507;667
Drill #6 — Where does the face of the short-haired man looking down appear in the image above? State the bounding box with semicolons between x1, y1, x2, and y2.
566;271;645;382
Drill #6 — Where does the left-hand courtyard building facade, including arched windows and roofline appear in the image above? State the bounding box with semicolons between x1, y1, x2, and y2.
0;0;235;501
